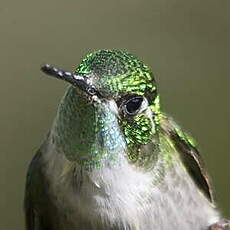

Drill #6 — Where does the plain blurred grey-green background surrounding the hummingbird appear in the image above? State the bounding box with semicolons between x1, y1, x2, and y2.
0;0;230;230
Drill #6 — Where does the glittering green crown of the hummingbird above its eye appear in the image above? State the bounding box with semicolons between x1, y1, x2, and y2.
76;50;156;97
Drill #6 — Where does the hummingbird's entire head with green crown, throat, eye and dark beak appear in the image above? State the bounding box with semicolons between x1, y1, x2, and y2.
42;50;161;167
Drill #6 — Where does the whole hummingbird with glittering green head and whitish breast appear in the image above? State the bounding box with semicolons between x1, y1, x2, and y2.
24;50;230;230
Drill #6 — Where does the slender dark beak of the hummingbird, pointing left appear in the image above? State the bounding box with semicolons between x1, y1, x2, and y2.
41;64;98;96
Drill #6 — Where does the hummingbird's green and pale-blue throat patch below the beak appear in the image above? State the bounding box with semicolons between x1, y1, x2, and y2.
52;87;126;168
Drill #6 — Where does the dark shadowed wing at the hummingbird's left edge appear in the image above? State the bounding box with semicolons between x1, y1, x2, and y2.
24;137;56;230
